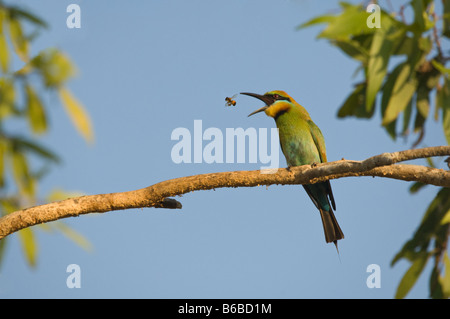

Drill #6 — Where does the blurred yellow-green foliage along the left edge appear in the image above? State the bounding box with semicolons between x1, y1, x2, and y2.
0;1;93;266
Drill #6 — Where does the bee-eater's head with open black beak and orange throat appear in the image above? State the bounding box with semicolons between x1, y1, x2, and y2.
241;90;296;118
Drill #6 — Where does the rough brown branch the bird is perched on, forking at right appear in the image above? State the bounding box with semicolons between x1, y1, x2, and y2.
0;146;450;240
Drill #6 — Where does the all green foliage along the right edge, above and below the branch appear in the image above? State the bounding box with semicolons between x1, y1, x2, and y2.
298;0;450;298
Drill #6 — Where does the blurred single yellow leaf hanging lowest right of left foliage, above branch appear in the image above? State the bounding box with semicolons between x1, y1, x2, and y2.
58;87;94;142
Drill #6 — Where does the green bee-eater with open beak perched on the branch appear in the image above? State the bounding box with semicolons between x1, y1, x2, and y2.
241;90;344;249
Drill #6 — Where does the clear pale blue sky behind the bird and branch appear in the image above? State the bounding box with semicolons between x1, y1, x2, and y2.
0;0;446;298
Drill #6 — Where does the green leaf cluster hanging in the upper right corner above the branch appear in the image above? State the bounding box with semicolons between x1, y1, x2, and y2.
298;0;450;144
